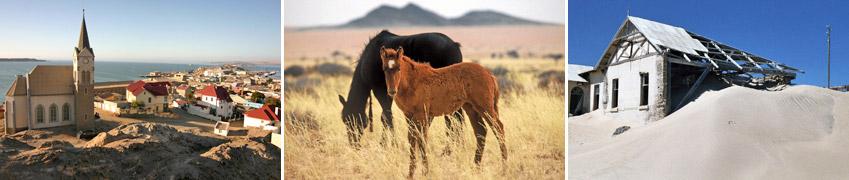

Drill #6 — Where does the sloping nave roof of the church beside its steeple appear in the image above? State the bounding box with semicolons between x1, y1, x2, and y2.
28;65;74;96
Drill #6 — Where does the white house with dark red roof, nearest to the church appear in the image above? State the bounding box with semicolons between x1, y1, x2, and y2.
126;80;170;112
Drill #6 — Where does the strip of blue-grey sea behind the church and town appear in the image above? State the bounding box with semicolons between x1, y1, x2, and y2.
0;61;282;101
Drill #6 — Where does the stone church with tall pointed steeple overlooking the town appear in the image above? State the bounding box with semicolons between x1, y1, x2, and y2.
3;15;94;134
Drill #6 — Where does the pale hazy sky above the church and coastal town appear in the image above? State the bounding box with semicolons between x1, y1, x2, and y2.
0;0;281;62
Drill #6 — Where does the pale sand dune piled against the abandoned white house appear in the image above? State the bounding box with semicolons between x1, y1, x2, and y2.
568;86;849;179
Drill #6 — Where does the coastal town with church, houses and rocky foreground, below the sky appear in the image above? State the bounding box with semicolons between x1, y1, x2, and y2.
0;11;283;179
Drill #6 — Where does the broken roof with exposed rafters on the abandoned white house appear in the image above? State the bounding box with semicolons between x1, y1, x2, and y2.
596;16;804;82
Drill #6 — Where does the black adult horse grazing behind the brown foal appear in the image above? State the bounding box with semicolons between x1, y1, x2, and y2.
339;30;463;146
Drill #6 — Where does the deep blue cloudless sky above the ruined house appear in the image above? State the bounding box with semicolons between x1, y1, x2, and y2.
568;0;849;86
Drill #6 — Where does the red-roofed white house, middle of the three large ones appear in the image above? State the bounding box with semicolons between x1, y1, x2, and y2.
191;85;236;118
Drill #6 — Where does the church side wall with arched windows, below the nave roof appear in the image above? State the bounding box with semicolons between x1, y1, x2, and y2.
29;95;76;129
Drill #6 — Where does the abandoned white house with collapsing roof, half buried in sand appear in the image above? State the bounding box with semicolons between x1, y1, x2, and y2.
569;16;802;121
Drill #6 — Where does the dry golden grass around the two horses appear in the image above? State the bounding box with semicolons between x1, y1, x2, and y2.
284;60;566;179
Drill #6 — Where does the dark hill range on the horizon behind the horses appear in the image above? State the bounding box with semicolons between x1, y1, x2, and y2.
333;3;551;28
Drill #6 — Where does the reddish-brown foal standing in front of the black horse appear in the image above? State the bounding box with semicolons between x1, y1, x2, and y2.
380;47;507;177
